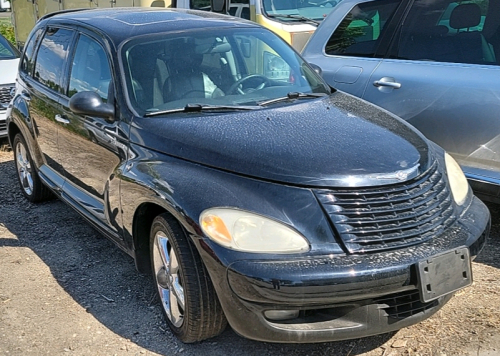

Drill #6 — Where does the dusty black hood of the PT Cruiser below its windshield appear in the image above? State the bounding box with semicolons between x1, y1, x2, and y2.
132;92;429;187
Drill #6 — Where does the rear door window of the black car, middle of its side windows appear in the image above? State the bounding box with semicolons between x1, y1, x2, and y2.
34;28;74;93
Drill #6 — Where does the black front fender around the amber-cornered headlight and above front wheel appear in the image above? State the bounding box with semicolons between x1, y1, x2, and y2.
121;145;342;264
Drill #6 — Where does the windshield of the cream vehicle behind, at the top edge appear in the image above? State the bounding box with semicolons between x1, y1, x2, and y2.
262;0;341;22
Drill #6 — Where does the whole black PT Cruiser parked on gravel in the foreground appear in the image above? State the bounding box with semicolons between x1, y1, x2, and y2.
7;9;490;342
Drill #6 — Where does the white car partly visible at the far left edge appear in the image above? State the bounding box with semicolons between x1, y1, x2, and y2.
0;35;20;139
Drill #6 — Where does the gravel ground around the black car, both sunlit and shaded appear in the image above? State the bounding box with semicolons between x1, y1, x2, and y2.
0;146;500;356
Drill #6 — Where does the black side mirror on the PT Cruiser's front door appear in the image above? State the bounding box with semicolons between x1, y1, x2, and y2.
69;91;115;122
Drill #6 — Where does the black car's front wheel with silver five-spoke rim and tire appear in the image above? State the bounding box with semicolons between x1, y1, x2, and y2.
150;213;227;343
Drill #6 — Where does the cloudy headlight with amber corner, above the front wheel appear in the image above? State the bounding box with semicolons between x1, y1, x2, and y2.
200;208;309;253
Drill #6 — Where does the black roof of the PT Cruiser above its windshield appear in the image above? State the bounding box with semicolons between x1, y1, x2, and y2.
41;7;260;44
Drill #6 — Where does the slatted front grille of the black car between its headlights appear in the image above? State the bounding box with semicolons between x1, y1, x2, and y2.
315;163;456;253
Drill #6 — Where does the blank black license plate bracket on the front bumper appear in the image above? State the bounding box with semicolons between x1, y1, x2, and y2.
417;247;472;303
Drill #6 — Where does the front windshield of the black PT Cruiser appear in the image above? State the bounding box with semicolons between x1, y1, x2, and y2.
122;28;330;116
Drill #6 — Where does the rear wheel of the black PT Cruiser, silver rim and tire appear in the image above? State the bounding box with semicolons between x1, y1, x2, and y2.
12;134;52;203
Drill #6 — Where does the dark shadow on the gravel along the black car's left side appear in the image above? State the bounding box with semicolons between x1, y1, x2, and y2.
0;161;394;356
